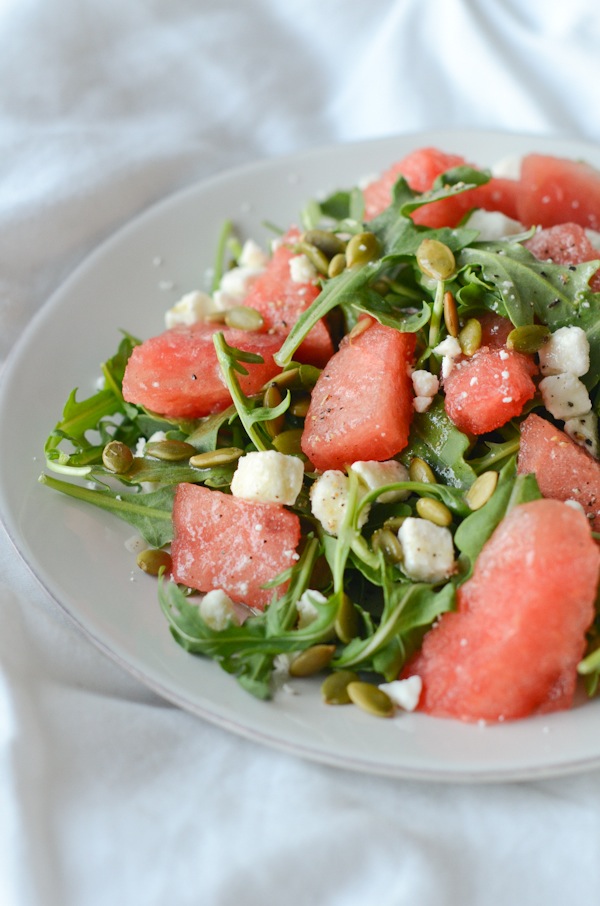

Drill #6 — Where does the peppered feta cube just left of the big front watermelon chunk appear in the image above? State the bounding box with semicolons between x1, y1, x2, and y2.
398;516;454;582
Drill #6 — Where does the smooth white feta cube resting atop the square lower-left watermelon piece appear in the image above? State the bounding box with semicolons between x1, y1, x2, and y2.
231;450;304;506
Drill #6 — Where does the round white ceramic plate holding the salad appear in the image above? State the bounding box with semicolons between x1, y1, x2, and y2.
0;132;600;781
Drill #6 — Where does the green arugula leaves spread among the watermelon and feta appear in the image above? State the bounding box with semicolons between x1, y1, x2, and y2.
40;167;600;698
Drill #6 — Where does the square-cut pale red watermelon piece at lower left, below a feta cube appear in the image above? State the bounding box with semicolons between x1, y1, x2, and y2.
171;483;300;610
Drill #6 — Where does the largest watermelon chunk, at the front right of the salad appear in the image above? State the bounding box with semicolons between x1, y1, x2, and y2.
403;500;600;722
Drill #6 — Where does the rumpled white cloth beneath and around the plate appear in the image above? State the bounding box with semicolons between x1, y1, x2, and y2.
0;0;600;906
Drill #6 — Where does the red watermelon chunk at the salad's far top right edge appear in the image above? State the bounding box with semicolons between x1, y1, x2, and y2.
517;154;600;230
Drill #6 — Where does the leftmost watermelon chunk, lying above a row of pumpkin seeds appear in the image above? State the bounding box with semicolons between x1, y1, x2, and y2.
123;322;281;418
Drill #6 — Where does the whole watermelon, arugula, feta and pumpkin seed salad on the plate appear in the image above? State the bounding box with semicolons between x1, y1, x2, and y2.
40;148;600;723
